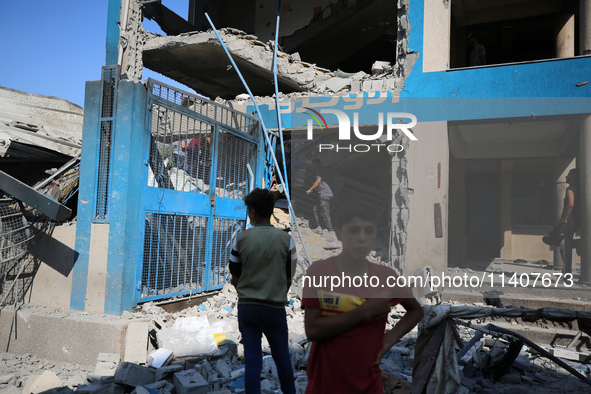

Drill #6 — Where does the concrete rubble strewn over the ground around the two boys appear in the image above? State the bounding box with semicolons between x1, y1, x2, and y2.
0;219;591;394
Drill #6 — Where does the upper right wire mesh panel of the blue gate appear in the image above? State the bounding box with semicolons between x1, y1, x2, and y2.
215;130;258;200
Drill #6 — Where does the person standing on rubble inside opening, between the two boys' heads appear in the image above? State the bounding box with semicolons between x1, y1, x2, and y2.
306;158;333;235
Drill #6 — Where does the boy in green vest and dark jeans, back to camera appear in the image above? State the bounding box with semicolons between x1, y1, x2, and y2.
229;188;297;394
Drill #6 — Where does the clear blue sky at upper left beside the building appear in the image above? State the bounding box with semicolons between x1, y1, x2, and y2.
0;0;189;107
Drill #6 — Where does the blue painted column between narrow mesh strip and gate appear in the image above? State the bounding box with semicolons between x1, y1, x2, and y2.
105;80;148;315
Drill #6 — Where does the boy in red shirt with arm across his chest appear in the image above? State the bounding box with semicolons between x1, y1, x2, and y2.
302;204;423;394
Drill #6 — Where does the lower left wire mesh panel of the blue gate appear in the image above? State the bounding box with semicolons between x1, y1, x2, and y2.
141;213;208;298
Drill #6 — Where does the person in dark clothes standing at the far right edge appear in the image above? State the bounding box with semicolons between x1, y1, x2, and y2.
558;168;580;273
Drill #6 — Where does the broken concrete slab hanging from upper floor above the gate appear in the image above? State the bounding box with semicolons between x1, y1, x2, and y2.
143;29;328;98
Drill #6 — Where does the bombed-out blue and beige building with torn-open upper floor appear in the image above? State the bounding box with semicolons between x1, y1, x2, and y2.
2;0;591;390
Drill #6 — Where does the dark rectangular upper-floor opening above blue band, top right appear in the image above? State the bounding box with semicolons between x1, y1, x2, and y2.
450;0;579;69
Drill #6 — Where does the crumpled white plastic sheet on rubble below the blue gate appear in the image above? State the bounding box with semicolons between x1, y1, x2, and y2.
157;316;219;357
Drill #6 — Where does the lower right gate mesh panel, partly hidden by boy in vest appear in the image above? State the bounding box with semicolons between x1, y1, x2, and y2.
209;218;246;288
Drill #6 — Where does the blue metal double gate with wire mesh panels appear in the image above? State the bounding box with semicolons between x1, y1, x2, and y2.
136;80;264;302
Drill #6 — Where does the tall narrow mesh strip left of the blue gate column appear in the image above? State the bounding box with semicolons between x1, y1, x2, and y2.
95;66;119;220
